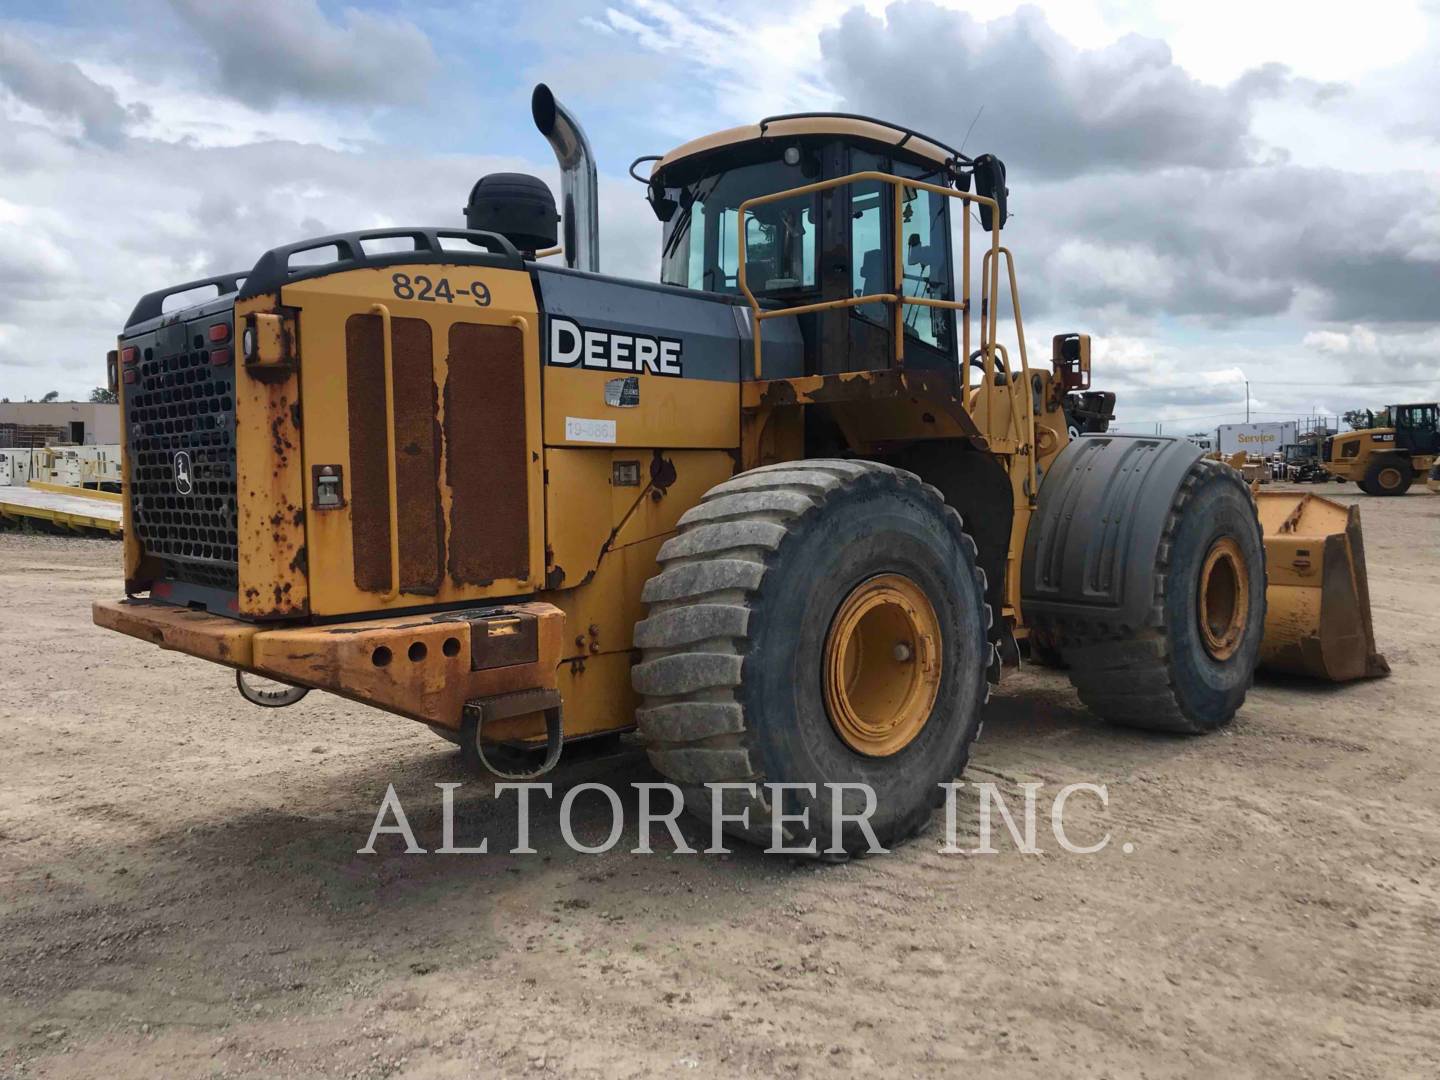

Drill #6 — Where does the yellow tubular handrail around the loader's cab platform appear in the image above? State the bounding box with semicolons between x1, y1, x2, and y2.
736;170;1035;445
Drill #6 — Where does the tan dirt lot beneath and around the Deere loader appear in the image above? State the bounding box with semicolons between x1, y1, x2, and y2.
0;485;1440;1077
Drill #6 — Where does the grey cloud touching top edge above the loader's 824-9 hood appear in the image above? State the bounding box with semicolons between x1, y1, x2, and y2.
170;0;436;108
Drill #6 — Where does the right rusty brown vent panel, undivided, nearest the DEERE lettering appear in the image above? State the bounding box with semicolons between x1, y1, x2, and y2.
445;323;530;585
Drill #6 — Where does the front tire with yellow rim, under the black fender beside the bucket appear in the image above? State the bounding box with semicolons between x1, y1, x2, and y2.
1050;458;1266;734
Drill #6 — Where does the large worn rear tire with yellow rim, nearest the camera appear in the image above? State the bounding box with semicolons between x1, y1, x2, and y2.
634;459;994;858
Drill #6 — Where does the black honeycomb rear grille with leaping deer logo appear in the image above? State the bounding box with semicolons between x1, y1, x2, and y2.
125;315;239;592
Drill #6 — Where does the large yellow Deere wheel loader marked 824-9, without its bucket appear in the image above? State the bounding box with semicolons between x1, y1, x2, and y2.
95;86;1342;852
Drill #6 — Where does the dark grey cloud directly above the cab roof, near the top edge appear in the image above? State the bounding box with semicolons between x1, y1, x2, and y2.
819;0;1287;176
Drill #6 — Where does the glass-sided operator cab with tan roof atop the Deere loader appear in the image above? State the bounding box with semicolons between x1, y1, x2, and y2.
645;114;1002;374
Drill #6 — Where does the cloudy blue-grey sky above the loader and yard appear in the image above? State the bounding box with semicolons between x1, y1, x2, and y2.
0;0;1440;433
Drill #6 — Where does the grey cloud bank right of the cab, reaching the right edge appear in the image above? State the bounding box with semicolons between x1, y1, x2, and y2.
1031;164;1440;323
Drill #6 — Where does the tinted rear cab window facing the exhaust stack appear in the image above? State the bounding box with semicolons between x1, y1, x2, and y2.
660;161;819;297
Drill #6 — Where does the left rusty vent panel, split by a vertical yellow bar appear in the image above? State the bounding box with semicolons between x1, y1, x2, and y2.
346;315;445;595
